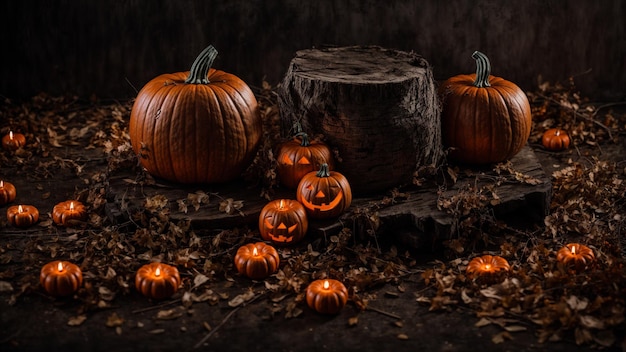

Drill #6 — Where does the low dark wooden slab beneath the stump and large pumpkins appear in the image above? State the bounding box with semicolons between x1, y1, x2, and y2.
107;146;552;247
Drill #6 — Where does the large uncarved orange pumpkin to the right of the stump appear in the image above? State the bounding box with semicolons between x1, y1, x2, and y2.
439;51;532;165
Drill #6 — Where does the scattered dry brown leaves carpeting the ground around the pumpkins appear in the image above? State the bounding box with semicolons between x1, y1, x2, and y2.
0;77;626;347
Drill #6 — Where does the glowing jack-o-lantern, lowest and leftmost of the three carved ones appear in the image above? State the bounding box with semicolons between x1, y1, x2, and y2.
259;199;309;245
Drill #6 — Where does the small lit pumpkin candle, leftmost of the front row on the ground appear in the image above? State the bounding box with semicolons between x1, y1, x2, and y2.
39;260;83;296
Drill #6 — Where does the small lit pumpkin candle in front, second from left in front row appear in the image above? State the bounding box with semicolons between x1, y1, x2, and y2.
135;263;180;300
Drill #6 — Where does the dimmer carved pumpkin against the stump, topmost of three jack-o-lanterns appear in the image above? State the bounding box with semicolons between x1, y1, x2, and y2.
276;133;333;188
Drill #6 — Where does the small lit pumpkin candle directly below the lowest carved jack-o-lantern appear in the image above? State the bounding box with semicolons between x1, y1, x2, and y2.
235;242;280;280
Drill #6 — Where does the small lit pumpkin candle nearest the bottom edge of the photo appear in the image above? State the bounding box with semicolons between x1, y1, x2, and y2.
306;279;348;314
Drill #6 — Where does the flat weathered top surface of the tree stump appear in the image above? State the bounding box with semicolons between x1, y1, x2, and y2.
291;46;429;84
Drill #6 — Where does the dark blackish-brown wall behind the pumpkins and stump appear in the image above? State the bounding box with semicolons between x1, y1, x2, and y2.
0;0;626;101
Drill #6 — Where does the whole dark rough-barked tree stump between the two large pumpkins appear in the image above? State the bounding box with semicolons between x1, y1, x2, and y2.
278;46;442;195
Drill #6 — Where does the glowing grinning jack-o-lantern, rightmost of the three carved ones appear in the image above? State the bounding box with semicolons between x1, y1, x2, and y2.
296;164;352;219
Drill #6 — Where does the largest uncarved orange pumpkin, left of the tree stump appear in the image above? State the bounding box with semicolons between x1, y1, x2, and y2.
129;46;262;183
